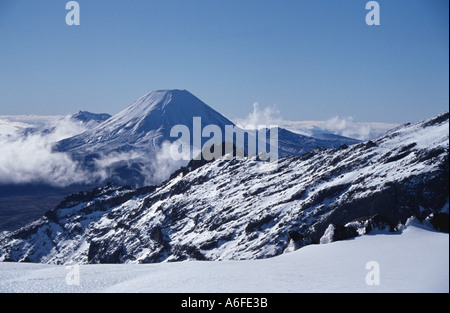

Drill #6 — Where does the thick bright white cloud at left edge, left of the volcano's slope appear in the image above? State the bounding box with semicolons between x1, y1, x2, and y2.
0;117;90;187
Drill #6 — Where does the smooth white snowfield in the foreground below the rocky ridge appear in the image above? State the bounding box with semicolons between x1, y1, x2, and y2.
0;226;449;293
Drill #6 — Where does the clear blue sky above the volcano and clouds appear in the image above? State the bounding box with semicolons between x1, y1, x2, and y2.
0;0;449;123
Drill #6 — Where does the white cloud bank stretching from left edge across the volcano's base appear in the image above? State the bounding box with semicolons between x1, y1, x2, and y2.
0;116;187;187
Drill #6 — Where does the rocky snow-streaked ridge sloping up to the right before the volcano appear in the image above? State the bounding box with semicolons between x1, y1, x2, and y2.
0;113;449;264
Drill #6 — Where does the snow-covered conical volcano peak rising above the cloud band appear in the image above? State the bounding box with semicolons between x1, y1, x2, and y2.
57;90;234;152
